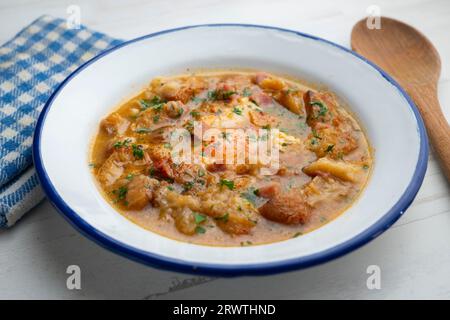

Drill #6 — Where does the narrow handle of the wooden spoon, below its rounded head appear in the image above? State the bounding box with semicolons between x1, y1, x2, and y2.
406;85;450;181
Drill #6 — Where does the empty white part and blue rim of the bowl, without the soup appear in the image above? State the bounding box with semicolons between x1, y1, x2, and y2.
33;24;428;275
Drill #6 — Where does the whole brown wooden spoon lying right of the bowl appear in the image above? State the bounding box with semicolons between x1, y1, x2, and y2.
351;17;450;181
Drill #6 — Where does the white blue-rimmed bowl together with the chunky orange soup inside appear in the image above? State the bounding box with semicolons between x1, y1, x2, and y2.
34;25;428;275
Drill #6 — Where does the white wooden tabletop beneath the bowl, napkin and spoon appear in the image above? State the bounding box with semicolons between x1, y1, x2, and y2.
0;0;450;299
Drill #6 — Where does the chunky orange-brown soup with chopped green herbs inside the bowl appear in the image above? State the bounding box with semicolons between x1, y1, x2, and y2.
90;71;373;246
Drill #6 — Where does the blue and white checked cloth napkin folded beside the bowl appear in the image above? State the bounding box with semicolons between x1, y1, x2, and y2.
0;16;121;228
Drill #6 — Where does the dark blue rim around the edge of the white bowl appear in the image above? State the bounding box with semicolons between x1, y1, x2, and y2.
33;23;428;276
